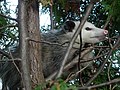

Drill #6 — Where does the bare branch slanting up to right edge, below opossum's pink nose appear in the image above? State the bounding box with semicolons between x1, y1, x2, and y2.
86;36;120;86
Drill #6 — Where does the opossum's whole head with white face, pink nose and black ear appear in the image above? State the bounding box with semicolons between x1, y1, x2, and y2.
65;21;108;43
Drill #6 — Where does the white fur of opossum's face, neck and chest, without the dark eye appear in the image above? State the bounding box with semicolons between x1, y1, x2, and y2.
73;21;108;70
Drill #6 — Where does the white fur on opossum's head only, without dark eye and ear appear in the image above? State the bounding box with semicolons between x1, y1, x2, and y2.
67;21;108;43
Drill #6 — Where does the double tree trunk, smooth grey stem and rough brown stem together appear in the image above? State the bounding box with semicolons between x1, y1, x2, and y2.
19;0;44;90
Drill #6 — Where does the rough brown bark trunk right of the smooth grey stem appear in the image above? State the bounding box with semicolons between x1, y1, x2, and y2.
28;0;44;87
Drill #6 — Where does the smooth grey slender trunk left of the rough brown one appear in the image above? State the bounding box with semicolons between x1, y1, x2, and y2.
18;0;32;90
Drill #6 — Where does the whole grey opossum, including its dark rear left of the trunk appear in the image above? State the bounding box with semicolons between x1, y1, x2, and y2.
0;21;108;90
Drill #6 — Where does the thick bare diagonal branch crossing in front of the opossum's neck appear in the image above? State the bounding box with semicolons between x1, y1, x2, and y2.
56;1;95;78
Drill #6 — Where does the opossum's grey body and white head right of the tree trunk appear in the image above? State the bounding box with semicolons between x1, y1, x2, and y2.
42;21;108;77
